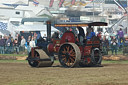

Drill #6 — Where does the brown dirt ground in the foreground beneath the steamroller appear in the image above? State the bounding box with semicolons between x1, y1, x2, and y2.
0;63;128;85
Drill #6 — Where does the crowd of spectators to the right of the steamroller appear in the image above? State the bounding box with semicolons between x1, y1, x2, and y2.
101;28;128;55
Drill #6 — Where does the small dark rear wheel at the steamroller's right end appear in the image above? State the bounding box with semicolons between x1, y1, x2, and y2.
91;48;102;65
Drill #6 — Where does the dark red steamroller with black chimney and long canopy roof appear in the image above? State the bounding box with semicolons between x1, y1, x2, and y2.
27;21;107;68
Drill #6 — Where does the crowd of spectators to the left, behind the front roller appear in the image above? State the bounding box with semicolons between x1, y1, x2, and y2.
0;33;39;54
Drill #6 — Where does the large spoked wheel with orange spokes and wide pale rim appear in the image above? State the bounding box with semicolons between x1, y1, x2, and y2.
58;43;81;68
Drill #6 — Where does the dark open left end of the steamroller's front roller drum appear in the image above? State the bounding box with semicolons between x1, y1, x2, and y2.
28;51;39;67
